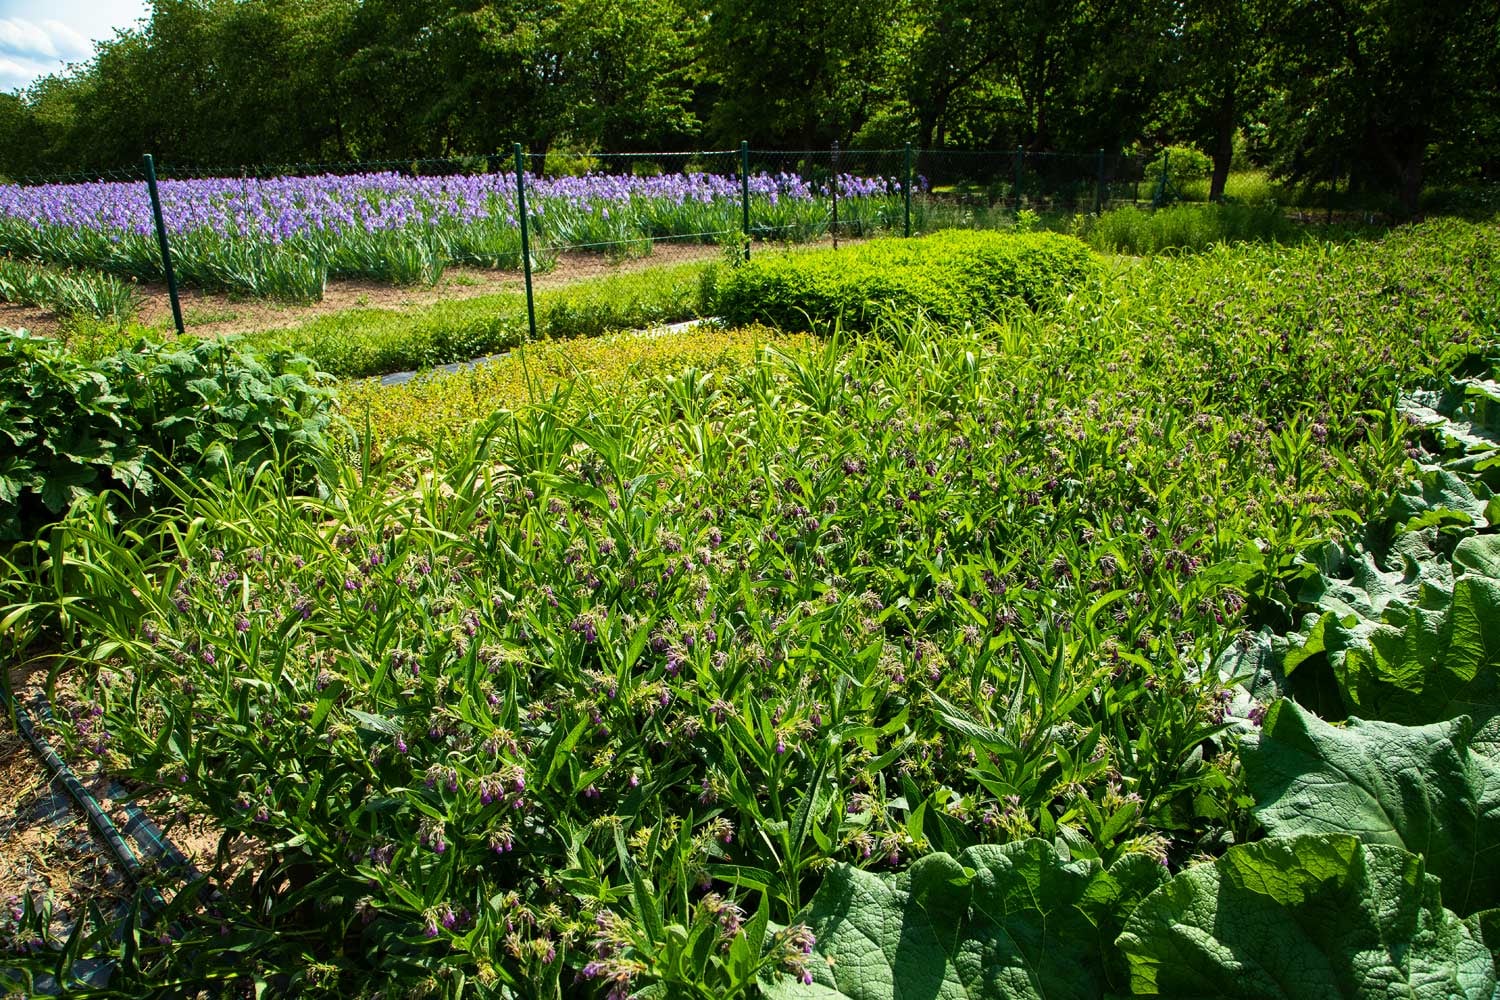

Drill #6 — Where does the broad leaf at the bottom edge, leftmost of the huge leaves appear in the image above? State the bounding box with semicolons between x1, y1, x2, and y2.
768;840;1167;1000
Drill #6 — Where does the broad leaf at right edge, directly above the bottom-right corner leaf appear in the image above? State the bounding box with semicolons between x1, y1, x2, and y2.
1241;702;1500;916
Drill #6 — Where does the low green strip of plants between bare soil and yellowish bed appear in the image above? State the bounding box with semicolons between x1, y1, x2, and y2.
249;264;704;378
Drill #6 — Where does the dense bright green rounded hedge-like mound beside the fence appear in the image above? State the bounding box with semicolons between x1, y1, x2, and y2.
713;229;1100;331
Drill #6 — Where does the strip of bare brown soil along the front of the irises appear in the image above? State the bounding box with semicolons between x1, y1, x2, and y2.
0;243;722;337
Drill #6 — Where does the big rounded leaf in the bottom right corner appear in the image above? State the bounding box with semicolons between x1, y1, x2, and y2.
1118;834;1496;1000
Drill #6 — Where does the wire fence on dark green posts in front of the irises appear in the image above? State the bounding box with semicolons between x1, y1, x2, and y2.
0;145;1172;353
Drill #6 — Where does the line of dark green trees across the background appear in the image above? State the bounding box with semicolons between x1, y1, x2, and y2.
0;0;1500;208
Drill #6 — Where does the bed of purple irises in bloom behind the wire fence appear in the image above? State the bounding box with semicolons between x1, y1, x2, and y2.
0;172;903;300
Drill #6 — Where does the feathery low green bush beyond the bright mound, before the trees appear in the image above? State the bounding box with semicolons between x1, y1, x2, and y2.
1080;204;1302;255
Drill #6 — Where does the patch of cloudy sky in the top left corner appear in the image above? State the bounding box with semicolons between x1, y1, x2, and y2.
0;0;146;91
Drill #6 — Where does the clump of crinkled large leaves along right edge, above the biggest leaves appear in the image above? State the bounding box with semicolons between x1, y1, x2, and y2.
1283;379;1500;729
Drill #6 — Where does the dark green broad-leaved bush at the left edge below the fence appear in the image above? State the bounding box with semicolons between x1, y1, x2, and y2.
0;330;335;540
